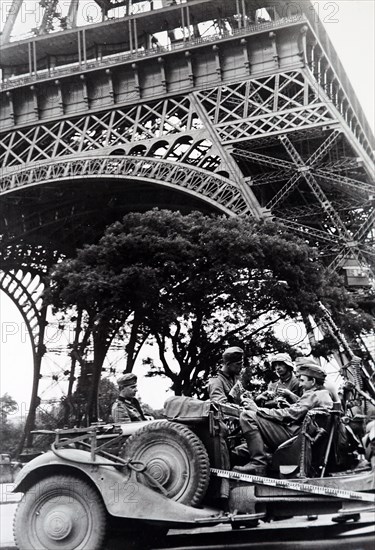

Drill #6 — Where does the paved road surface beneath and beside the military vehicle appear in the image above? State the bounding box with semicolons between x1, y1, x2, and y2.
0;483;375;550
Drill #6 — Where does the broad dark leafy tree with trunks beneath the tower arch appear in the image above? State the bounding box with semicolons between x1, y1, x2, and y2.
48;209;366;412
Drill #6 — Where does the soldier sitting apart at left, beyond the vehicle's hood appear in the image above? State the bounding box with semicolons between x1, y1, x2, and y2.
112;373;146;424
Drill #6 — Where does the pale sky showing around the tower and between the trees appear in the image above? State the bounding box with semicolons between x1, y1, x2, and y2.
0;0;375;414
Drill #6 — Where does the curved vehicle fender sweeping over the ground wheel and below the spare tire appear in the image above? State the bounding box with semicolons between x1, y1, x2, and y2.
13;448;220;527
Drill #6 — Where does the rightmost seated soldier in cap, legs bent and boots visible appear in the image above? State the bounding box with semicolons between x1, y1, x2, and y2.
234;361;333;475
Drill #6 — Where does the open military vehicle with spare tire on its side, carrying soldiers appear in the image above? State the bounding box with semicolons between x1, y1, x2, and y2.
14;358;375;550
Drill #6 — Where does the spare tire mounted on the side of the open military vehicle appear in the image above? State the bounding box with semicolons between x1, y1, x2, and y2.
120;420;210;506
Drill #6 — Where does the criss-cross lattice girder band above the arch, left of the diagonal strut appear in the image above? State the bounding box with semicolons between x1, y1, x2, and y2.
0;96;203;170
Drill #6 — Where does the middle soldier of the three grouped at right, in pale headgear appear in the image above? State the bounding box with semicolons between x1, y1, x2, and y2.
255;353;302;408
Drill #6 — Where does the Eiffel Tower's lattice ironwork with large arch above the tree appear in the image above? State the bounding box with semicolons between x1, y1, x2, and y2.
0;0;375;440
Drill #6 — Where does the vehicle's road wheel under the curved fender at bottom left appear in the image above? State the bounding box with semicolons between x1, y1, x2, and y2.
13;475;106;550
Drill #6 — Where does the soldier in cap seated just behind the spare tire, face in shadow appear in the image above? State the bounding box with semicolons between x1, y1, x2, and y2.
208;346;244;405
